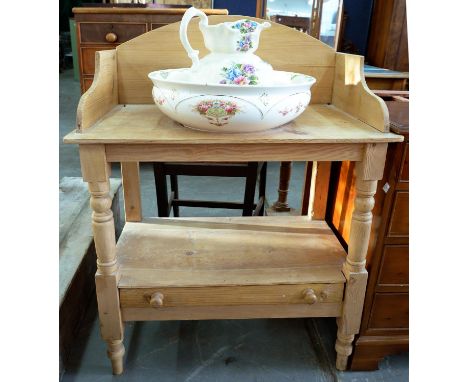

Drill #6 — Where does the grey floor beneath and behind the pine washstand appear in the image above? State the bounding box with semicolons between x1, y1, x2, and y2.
59;70;408;382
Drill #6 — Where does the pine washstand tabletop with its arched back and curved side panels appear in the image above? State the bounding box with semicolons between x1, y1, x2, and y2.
65;15;403;151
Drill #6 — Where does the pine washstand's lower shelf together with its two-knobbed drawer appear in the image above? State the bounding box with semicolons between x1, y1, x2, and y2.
117;216;346;321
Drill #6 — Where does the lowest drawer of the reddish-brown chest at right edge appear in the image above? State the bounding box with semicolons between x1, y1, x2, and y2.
369;293;409;329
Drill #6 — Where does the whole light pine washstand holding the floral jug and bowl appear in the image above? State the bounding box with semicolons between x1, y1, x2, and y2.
65;16;403;374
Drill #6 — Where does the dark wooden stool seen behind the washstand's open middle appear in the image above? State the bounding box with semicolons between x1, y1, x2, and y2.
153;162;267;217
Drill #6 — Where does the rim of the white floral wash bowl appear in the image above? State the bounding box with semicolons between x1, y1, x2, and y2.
148;68;317;89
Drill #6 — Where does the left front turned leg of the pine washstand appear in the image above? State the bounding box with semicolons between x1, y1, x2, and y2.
80;145;125;374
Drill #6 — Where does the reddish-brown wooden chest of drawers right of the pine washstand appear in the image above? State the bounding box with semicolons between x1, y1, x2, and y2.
327;97;409;370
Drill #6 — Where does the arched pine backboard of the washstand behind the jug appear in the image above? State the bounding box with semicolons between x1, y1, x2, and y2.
116;15;335;104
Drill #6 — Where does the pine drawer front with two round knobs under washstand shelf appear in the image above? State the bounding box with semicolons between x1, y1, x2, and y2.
120;284;343;308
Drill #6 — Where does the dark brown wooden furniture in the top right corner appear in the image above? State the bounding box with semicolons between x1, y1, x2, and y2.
366;0;409;72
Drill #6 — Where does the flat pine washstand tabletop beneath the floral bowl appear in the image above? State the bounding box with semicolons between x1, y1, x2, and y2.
64;105;403;145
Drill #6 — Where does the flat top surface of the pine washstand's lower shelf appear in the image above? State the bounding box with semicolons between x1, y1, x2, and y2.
117;216;346;288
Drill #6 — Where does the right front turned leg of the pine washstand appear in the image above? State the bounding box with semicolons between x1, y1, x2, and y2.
335;144;387;370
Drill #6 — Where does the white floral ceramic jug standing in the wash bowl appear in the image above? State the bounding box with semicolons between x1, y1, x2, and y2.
179;8;273;86
